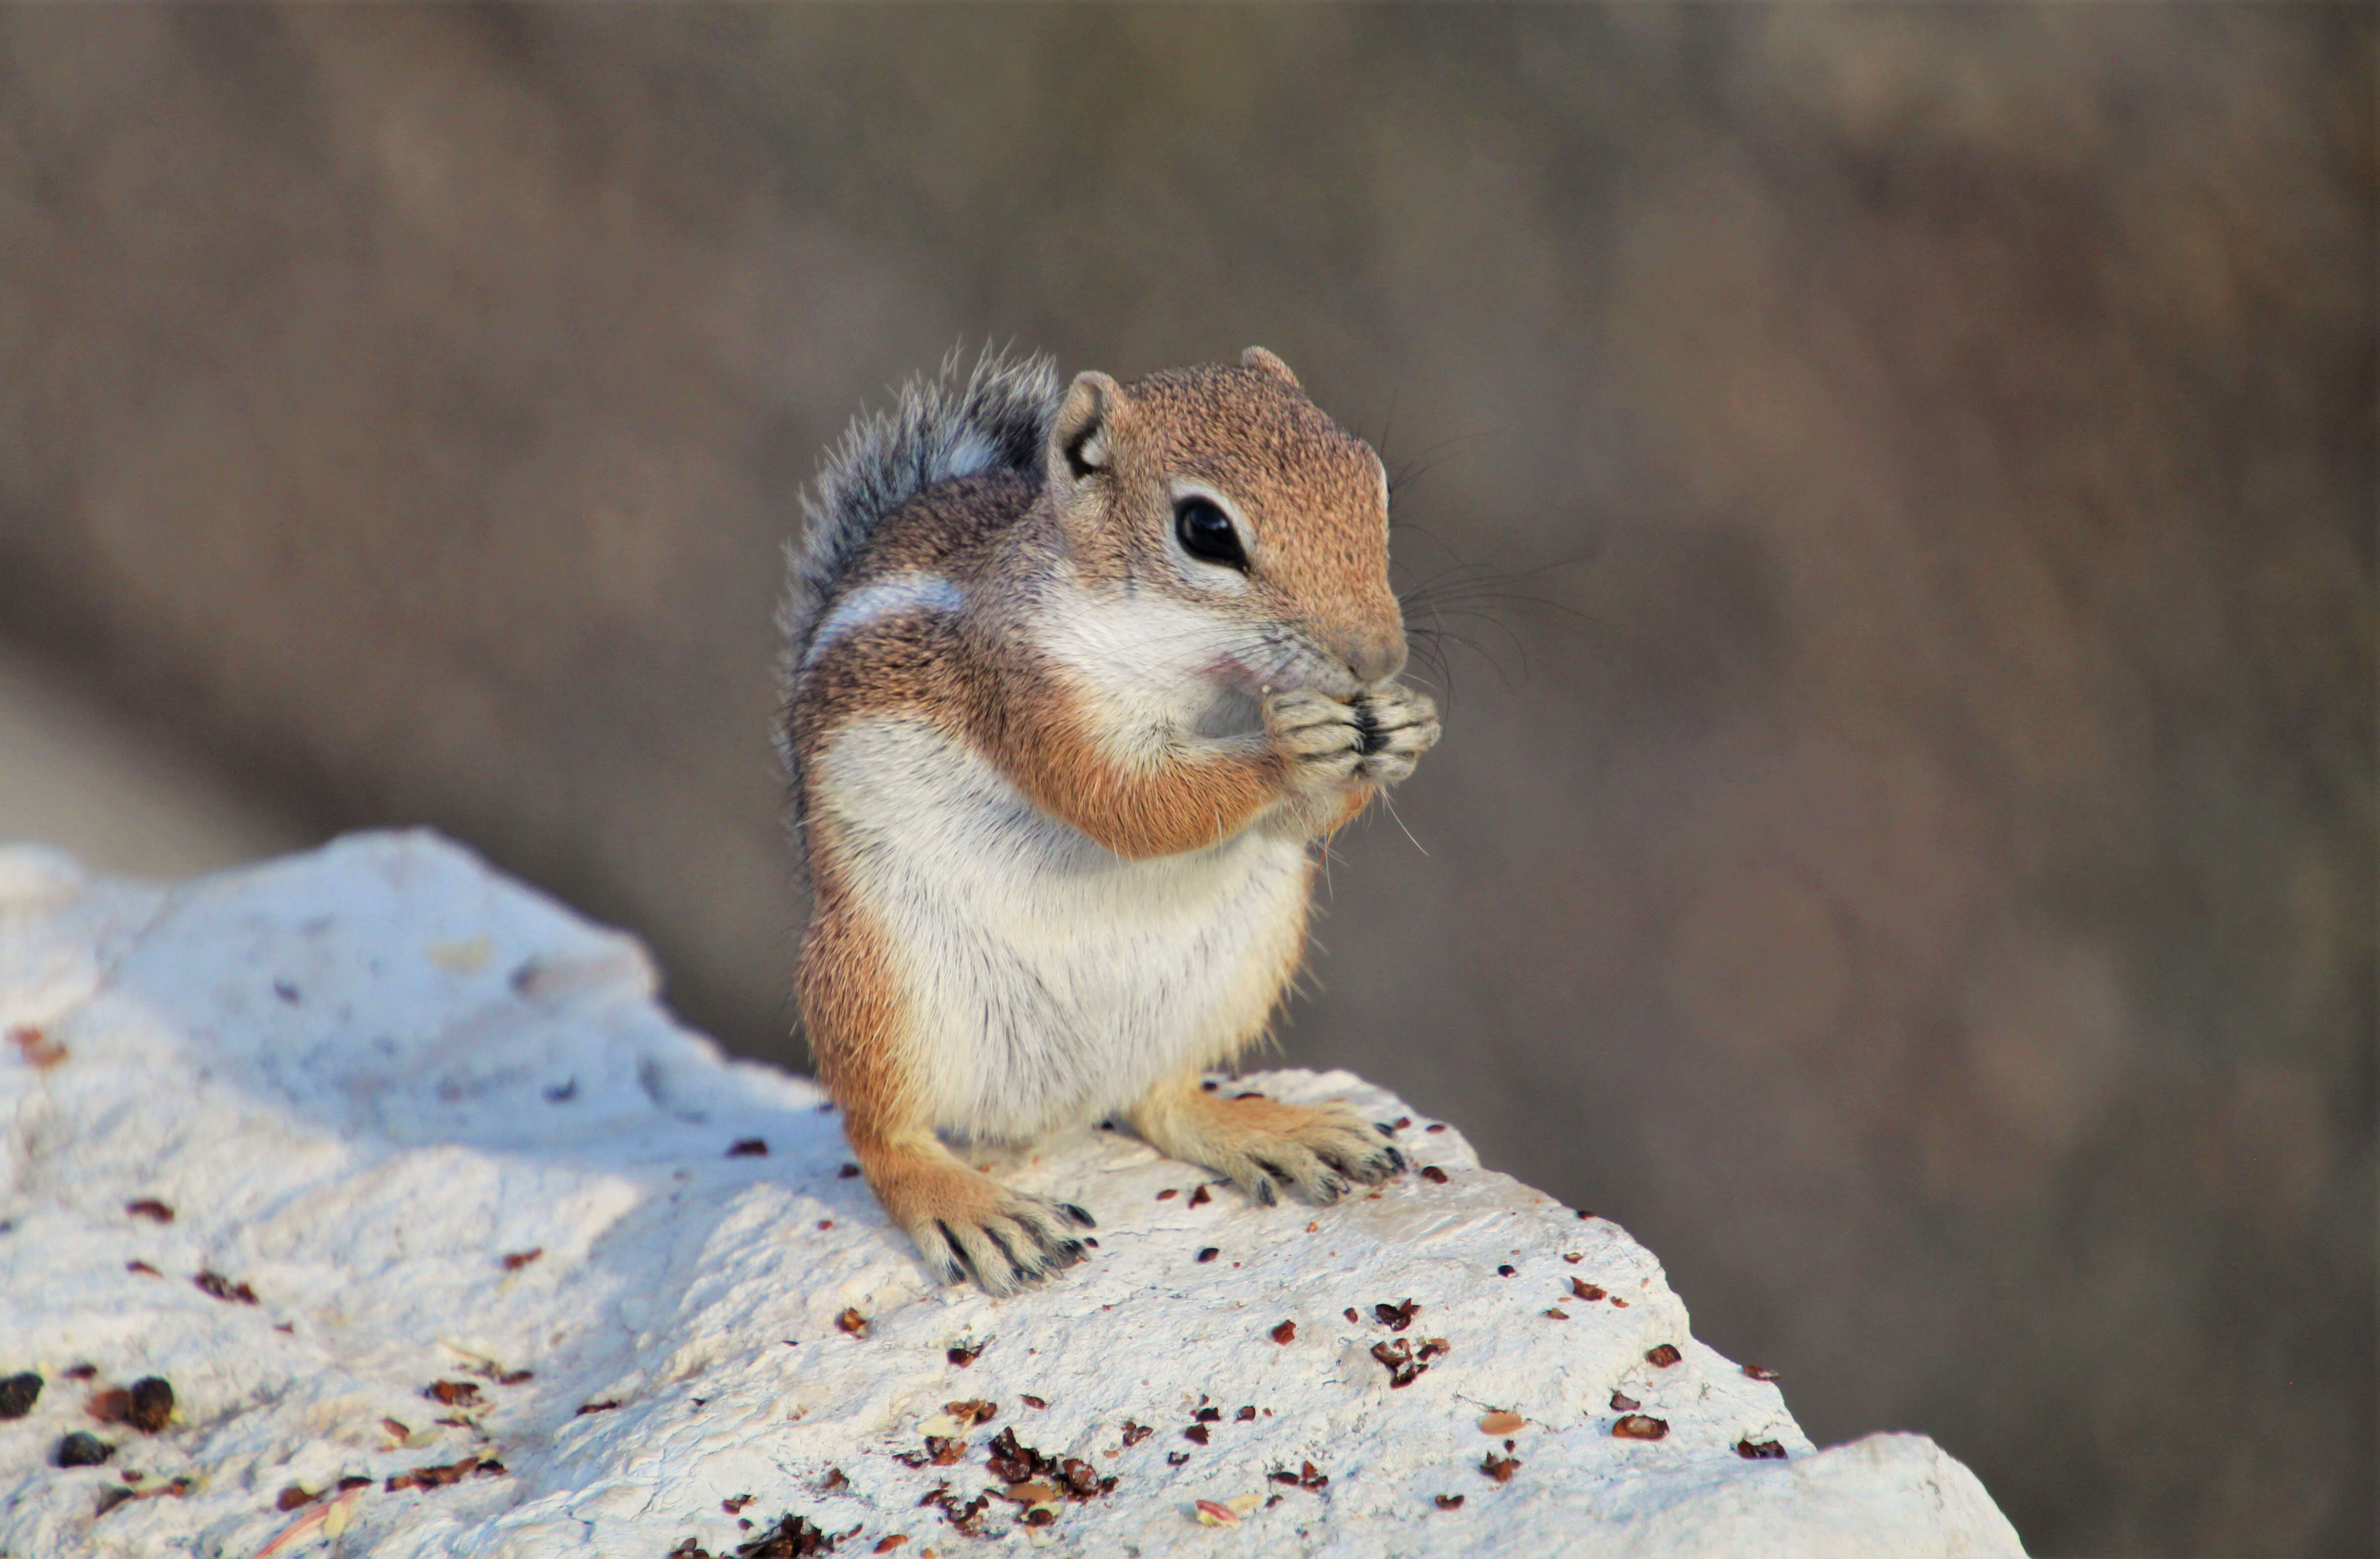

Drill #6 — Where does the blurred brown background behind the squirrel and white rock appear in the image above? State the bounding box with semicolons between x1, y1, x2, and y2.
0;5;2375;1554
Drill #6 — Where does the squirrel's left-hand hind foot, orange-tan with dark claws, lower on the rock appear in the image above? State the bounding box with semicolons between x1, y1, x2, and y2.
855;1135;1093;1299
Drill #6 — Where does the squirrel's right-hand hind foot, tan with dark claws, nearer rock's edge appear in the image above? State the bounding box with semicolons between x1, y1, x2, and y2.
1126;1073;1404;1207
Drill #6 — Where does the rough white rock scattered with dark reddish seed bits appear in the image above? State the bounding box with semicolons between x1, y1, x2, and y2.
0;833;2020;1559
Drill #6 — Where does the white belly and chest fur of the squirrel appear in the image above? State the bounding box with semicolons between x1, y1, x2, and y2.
812;719;1307;1140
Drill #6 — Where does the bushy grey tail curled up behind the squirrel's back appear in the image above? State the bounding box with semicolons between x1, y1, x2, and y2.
778;348;1059;666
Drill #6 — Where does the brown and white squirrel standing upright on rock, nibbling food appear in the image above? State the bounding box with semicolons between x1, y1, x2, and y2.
783;348;1437;1295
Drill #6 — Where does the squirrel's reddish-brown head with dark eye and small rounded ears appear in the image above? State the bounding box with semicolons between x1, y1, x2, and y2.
1043;348;1404;697
